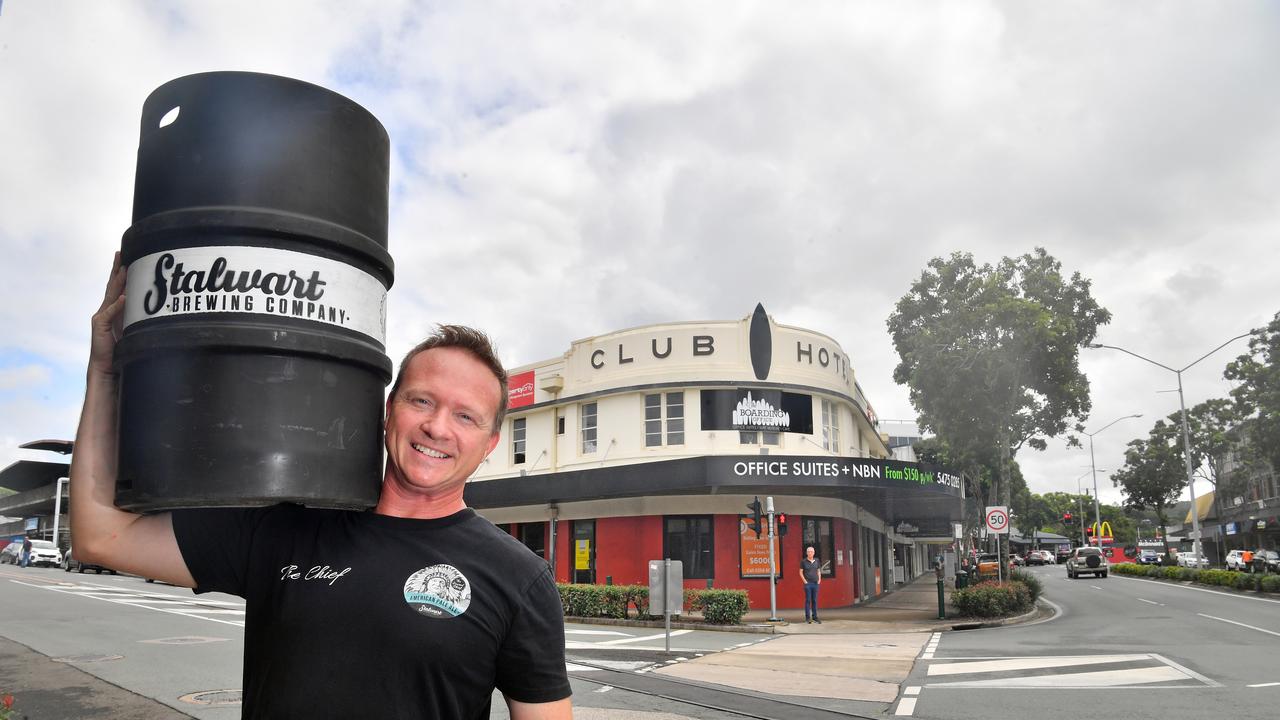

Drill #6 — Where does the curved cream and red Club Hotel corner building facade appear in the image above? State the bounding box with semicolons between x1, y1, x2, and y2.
466;306;961;609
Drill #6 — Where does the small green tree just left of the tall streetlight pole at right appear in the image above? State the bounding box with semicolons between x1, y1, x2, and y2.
1111;420;1187;555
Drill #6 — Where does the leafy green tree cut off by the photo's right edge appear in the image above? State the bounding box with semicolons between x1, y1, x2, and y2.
1222;313;1280;470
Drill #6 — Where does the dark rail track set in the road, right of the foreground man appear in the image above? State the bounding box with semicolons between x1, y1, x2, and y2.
568;657;873;720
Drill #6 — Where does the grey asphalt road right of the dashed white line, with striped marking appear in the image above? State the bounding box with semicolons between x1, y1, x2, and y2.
895;565;1280;720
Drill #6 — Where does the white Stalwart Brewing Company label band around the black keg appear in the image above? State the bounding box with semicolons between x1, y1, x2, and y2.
124;246;387;343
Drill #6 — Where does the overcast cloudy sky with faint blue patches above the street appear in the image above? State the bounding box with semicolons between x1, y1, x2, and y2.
0;0;1280;500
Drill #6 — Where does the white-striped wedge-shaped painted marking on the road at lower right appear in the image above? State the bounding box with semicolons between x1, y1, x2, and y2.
925;653;1221;689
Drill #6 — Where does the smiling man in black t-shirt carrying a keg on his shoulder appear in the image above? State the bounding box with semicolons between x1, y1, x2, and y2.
70;255;572;720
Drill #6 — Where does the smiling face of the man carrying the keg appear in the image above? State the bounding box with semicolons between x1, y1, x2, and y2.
387;347;502;500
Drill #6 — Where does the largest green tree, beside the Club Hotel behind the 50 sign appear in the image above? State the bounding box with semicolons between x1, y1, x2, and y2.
887;247;1111;505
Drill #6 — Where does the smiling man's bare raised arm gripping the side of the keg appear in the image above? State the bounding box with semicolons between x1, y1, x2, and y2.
70;252;196;588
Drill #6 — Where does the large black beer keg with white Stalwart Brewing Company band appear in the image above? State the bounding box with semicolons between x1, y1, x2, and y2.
115;72;393;511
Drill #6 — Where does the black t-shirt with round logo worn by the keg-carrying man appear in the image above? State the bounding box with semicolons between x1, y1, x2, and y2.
173;505;570;717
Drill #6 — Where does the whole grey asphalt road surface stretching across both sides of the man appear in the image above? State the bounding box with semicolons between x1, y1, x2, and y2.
10;566;1280;720
